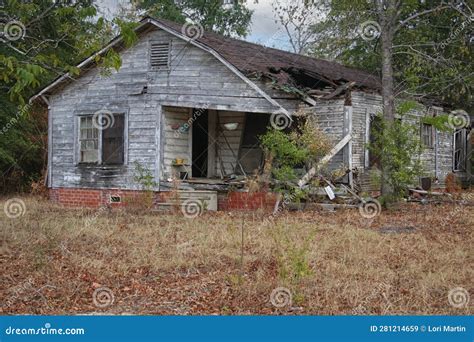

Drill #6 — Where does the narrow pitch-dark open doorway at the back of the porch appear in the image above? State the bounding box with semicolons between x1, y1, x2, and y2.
191;109;209;178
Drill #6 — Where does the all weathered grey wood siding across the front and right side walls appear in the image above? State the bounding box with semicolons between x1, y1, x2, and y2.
49;24;452;194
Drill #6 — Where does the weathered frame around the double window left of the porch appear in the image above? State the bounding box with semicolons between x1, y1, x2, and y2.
74;109;128;167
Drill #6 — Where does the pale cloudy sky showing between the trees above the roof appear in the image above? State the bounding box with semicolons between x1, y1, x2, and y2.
96;0;290;50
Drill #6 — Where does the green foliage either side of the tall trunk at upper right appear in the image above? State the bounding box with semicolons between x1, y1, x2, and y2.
311;0;474;111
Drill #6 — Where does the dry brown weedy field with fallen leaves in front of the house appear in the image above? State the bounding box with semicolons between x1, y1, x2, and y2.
0;197;474;315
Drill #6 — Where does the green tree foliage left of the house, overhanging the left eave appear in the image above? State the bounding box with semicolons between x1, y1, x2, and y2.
0;0;136;192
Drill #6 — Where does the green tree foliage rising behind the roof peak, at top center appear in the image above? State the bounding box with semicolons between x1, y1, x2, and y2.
137;0;252;37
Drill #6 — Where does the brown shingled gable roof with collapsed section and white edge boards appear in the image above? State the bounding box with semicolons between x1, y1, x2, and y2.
30;17;381;106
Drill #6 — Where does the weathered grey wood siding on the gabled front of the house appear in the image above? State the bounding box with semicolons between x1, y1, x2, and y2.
49;29;297;189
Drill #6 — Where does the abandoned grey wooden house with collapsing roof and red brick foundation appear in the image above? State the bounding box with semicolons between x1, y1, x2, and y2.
32;17;470;209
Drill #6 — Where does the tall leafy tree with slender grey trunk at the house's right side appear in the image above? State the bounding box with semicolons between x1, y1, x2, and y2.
313;0;474;198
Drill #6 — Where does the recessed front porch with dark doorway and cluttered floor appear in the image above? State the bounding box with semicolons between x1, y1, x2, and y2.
160;106;270;191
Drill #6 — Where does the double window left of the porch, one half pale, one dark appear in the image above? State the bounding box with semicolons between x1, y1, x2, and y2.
79;113;125;165
